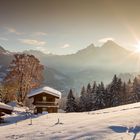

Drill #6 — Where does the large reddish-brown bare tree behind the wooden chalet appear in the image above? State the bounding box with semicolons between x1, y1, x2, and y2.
5;54;44;103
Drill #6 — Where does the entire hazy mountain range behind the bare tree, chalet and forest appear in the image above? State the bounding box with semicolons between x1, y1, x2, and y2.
0;41;140;94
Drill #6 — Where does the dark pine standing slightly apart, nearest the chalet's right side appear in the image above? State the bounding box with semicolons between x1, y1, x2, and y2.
66;89;77;112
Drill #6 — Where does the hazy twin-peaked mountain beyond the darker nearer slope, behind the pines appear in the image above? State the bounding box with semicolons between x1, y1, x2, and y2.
26;41;140;91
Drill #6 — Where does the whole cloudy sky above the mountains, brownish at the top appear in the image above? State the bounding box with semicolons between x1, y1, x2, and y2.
0;0;140;55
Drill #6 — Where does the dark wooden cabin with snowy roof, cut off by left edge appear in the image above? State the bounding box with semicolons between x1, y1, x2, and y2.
0;102;13;122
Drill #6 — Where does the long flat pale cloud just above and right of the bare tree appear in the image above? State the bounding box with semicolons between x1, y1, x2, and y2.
19;39;46;46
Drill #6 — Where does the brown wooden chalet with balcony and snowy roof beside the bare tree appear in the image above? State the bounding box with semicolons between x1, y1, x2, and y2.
28;87;61;114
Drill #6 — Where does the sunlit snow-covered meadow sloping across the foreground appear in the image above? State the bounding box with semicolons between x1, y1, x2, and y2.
0;103;140;140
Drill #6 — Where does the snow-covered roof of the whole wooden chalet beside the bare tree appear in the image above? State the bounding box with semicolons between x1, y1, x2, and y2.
27;86;61;98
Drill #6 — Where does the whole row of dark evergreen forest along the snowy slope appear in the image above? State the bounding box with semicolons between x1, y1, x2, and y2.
65;75;140;112
